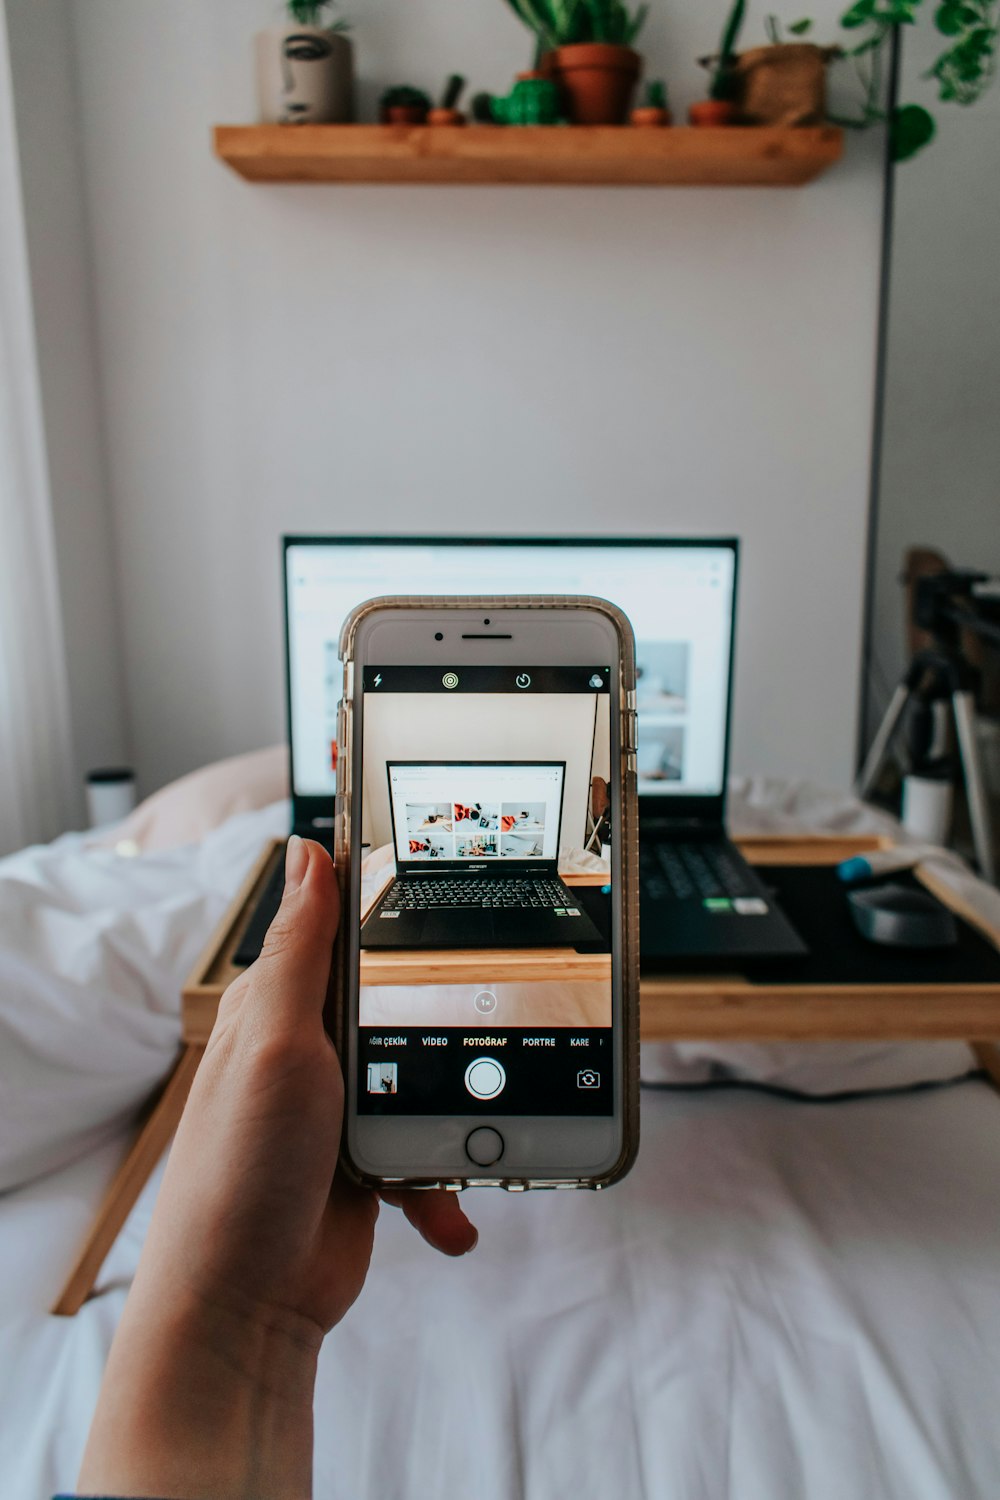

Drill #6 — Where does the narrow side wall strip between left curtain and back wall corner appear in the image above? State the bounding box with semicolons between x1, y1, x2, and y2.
6;0;129;818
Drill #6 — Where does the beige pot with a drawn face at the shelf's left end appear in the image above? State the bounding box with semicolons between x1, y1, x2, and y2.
253;0;354;125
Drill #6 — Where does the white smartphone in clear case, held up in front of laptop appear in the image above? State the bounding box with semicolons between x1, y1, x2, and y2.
336;597;639;1190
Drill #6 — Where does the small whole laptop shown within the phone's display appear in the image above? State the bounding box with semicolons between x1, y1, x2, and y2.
361;761;601;948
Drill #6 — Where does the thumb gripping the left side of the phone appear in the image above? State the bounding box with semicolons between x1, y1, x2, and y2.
251;834;340;1026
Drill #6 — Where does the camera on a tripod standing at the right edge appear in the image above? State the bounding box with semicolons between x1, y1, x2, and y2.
856;569;1000;881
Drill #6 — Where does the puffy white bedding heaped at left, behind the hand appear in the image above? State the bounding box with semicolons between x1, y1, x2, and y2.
0;803;288;1191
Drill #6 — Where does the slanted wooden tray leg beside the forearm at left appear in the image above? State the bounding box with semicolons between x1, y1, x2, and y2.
52;1046;205;1317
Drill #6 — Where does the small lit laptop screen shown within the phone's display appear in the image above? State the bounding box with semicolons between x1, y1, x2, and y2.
387;761;565;864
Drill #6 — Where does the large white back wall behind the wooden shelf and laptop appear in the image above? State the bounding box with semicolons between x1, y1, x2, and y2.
64;0;882;788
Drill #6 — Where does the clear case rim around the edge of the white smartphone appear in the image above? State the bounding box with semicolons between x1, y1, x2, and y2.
327;594;639;1191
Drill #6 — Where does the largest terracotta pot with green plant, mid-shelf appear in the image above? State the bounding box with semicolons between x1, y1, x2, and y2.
508;0;648;125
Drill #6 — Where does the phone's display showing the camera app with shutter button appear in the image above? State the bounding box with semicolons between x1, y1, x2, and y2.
358;665;615;1118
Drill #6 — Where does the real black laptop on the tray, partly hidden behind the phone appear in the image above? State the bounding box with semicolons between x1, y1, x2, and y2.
234;536;807;969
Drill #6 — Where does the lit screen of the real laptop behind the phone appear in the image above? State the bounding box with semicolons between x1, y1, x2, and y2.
285;537;738;800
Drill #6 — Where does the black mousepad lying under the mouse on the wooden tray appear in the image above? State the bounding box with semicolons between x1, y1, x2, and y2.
740;864;1000;986
